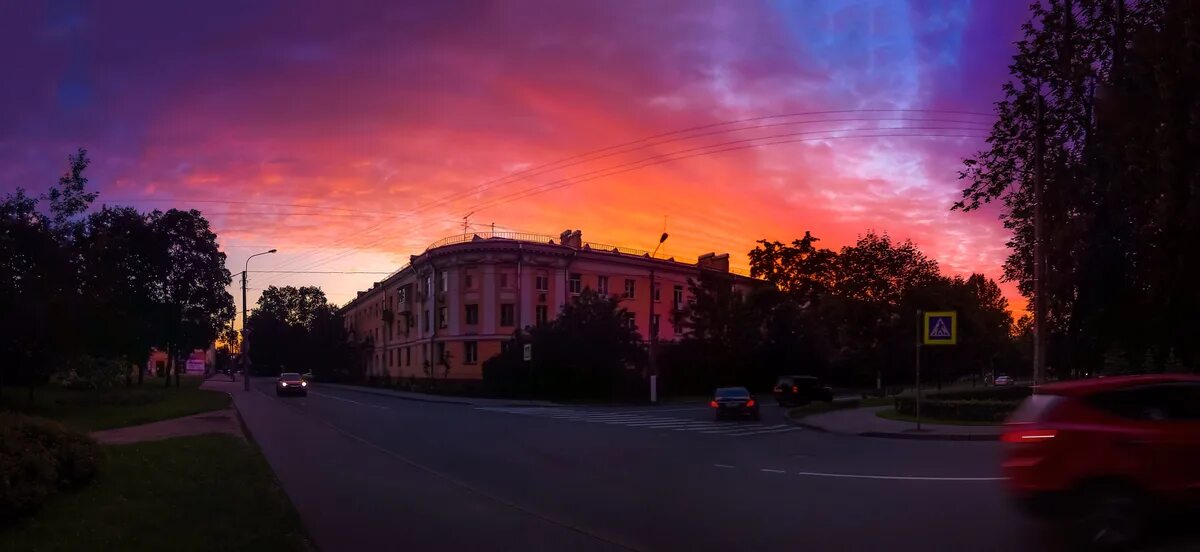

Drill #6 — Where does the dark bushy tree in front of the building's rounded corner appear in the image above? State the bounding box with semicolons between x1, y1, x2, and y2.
484;289;646;398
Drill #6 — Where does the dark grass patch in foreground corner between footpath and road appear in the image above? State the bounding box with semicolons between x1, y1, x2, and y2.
0;434;311;551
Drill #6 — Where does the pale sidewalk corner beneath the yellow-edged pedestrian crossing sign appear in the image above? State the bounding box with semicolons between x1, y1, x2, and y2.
788;407;1003;440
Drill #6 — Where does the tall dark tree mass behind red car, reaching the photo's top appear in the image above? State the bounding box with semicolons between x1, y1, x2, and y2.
955;0;1200;372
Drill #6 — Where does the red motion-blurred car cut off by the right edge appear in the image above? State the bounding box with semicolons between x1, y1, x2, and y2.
1001;374;1200;550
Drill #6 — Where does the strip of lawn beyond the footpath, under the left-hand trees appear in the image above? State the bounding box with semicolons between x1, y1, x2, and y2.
0;377;229;432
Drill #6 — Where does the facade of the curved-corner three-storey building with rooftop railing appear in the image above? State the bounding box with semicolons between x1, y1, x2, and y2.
341;230;756;379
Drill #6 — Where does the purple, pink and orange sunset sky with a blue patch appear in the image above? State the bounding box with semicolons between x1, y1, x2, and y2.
0;0;1027;319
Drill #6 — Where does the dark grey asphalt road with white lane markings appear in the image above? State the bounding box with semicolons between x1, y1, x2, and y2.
226;380;1194;551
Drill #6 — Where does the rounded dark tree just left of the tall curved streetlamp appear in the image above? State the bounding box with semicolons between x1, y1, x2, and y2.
149;209;236;386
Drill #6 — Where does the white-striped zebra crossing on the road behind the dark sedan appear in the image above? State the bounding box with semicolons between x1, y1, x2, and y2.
478;407;800;437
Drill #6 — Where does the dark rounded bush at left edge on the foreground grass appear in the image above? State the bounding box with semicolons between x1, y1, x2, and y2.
0;415;100;520
